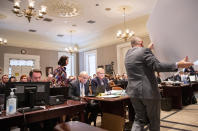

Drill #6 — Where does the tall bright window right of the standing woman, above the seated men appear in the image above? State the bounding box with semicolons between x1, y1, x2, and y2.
85;50;97;77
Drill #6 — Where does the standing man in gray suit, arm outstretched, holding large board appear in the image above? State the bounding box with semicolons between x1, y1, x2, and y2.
125;37;192;131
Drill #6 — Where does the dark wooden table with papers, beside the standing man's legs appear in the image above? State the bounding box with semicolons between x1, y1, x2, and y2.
84;96;134;131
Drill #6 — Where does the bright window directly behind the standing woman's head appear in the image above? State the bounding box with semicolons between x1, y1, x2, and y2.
58;52;75;77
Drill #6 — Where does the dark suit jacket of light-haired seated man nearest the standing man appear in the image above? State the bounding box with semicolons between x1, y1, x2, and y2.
91;77;110;94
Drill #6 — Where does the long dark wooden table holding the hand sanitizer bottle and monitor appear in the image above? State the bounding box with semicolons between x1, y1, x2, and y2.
0;100;87;129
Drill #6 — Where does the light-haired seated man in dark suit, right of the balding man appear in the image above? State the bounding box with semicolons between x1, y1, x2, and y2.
91;68;110;94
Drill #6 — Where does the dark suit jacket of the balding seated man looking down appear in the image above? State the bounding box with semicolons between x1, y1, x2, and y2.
69;80;89;100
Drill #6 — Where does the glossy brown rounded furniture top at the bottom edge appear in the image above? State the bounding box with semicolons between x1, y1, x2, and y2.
54;121;107;131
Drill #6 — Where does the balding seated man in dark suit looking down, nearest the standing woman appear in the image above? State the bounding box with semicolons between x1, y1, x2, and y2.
69;71;98;124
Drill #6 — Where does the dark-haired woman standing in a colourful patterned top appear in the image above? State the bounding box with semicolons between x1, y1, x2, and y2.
54;56;69;86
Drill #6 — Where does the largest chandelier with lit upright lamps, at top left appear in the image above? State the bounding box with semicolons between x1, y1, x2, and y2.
12;0;47;22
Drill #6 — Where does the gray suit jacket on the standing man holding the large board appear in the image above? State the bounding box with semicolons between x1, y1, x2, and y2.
125;47;177;99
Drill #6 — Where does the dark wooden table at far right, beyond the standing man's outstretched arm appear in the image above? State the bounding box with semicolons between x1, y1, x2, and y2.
161;84;193;109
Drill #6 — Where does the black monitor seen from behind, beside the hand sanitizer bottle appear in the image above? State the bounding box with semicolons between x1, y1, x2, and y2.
5;82;50;110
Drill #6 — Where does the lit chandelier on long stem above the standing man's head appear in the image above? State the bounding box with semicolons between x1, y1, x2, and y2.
117;8;135;42
